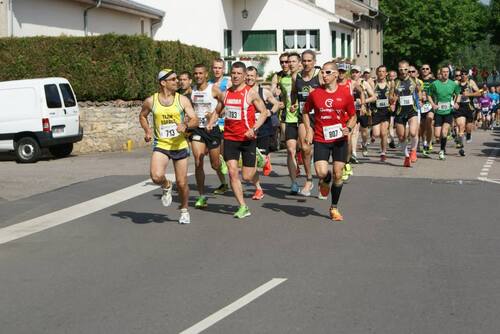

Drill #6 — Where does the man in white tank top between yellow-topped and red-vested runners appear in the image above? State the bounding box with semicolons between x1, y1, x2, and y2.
190;64;228;209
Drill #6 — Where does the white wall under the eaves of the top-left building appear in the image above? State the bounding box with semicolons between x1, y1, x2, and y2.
13;0;150;37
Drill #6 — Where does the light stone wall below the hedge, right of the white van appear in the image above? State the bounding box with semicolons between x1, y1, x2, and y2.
74;101;151;153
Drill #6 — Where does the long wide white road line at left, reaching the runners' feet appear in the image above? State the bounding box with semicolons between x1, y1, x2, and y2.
0;173;186;245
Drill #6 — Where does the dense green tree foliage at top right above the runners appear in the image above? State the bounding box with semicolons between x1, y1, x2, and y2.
380;0;491;67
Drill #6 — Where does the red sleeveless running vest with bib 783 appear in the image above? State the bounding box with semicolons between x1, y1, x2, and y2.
224;86;255;141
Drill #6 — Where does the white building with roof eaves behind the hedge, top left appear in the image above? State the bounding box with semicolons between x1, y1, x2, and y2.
0;0;165;37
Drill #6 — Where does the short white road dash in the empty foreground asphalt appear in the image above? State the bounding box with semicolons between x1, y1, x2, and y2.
180;278;287;334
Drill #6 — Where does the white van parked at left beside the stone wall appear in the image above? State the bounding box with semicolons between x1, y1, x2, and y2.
0;78;83;162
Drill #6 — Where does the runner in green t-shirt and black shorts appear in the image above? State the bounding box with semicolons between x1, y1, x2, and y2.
429;66;460;160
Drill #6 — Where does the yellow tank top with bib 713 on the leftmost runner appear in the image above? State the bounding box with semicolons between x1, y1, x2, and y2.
153;93;188;151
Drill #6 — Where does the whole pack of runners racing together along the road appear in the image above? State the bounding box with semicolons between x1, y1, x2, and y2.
139;50;500;224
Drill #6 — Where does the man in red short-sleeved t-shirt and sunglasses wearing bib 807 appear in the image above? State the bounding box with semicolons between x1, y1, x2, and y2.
303;62;356;221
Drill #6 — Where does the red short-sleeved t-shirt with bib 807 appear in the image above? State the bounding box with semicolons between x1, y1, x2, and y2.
304;86;356;143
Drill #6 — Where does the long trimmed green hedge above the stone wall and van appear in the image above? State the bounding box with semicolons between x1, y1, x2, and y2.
0;34;219;101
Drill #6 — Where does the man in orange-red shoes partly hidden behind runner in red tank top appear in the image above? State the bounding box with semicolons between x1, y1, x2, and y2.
246;66;279;200
